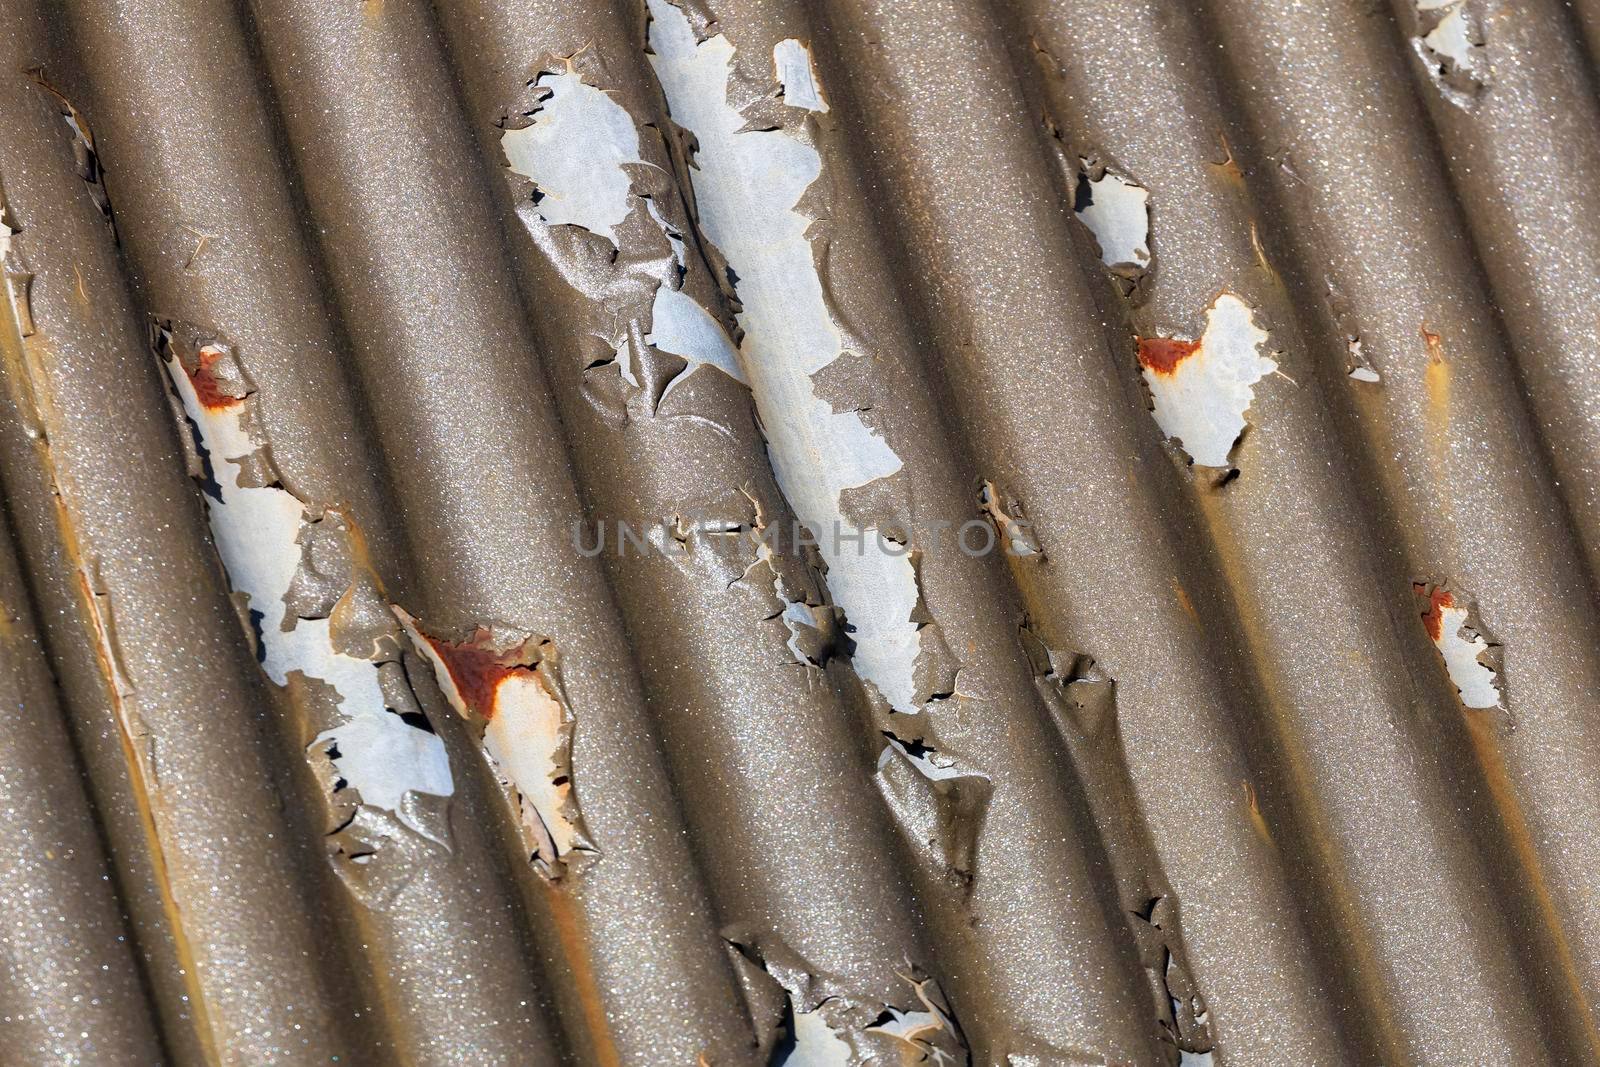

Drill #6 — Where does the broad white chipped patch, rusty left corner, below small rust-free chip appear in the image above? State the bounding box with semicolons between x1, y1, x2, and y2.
1138;293;1278;467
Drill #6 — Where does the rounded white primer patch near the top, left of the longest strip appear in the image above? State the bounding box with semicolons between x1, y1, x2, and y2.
501;72;643;246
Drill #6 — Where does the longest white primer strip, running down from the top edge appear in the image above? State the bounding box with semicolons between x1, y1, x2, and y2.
648;0;922;713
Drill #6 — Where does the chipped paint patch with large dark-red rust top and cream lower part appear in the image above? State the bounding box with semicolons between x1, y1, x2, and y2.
394;606;594;878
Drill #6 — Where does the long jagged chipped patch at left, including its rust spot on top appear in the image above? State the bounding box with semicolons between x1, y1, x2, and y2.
157;330;456;840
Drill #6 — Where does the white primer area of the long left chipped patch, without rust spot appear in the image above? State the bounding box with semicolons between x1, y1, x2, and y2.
166;349;456;837
